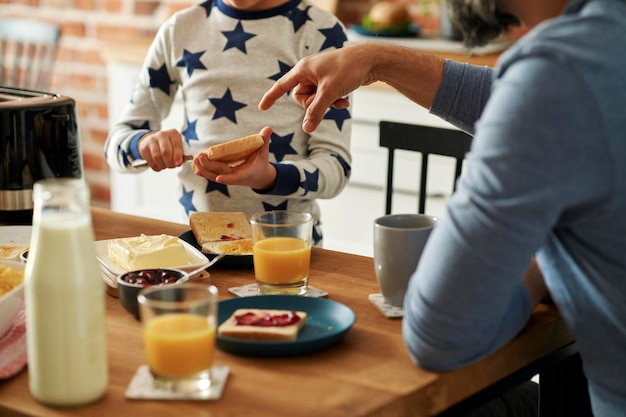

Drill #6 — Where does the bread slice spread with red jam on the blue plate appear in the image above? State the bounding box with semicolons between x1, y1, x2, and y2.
217;308;307;341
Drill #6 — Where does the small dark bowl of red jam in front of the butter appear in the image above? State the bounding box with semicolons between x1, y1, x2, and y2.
117;268;189;320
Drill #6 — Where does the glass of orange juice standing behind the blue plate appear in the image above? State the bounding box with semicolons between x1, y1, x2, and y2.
250;210;313;295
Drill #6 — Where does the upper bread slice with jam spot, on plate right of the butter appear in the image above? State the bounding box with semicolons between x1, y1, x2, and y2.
189;211;252;246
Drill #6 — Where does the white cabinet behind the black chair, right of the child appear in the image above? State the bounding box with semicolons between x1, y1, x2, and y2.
312;87;454;256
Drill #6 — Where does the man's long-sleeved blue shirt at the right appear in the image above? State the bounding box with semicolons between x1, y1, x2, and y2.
403;0;626;417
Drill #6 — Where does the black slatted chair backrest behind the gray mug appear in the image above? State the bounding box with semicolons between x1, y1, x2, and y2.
379;121;472;214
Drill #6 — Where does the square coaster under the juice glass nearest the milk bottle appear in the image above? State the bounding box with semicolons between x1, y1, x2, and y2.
125;365;230;400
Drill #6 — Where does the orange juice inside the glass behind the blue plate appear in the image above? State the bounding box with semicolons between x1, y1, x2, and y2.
253;237;311;284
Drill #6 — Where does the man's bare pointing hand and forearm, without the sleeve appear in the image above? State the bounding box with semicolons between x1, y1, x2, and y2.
259;43;444;132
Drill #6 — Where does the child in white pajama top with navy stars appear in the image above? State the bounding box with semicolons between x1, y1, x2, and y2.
105;0;352;245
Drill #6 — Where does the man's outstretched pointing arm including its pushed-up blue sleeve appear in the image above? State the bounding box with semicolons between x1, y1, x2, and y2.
259;43;493;133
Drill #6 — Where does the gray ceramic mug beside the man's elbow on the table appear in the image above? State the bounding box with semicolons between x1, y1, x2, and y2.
374;214;439;307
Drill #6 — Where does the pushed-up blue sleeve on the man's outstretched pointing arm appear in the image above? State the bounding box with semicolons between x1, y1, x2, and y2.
430;60;494;134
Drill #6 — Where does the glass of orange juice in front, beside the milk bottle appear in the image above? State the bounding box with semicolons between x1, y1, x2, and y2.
137;284;217;397
